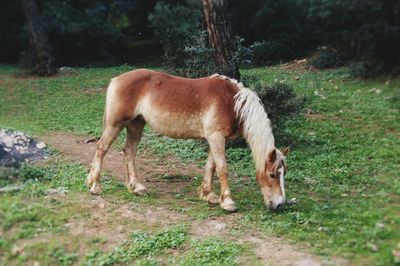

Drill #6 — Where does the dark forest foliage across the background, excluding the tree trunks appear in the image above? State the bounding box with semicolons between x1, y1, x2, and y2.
0;0;400;77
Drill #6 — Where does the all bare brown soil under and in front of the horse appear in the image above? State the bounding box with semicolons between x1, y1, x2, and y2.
41;133;347;266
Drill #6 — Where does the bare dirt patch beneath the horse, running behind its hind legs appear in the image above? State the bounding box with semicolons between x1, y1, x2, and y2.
41;132;203;193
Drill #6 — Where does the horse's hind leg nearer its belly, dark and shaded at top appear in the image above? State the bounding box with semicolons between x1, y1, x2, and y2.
124;118;146;195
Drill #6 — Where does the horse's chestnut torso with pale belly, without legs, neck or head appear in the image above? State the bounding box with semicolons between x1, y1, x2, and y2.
105;69;241;138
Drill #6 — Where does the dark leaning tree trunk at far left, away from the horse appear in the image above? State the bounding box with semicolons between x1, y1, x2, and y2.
21;0;56;76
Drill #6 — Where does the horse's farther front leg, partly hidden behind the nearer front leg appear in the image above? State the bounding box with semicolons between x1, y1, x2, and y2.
199;150;219;204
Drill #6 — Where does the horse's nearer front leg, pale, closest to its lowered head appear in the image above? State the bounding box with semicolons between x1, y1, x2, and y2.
207;132;236;212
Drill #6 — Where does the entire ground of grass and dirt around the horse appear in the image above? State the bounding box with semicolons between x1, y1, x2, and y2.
0;63;400;265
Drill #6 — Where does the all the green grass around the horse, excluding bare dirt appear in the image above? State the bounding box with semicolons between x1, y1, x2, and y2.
0;63;400;265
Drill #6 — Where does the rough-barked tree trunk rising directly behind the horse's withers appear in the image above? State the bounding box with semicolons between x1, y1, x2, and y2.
203;0;240;80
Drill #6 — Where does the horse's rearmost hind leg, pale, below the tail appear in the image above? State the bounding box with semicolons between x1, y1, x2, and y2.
87;125;122;195
